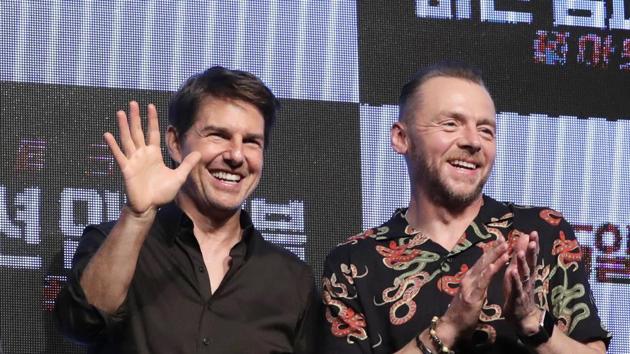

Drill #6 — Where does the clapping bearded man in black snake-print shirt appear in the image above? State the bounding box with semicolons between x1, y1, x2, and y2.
323;63;610;354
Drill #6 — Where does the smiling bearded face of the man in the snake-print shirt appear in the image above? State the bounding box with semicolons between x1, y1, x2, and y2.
392;77;496;208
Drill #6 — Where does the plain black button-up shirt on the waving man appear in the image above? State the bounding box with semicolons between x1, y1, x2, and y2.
55;204;321;354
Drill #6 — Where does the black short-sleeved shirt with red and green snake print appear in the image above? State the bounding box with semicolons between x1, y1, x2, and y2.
322;196;610;354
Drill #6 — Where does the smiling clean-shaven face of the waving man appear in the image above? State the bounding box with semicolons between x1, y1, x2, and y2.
168;97;265;214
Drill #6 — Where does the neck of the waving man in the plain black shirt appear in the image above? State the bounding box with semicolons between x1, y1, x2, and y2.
175;192;242;245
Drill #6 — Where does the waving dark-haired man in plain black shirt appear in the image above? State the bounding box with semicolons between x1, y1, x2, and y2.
55;67;320;354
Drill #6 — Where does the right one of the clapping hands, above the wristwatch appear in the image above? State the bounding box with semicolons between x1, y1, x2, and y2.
503;231;541;334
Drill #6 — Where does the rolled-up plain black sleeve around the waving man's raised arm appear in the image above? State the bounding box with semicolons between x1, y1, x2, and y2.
54;226;124;344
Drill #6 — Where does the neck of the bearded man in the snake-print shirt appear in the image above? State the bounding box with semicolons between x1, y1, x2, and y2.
406;190;483;251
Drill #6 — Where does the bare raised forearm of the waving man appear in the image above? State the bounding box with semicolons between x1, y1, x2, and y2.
80;207;156;314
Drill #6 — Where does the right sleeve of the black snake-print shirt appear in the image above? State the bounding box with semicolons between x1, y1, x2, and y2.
540;213;611;346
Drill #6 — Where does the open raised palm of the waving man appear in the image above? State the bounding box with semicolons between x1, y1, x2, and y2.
104;101;201;215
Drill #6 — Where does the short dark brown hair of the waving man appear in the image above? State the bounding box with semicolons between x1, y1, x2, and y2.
168;66;280;148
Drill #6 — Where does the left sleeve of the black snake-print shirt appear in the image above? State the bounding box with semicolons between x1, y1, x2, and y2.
322;249;373;354
